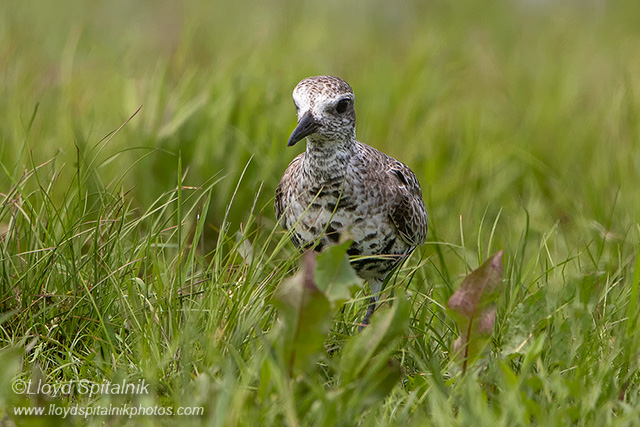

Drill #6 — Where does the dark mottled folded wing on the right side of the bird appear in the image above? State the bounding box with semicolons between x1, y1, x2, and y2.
387;161;427;247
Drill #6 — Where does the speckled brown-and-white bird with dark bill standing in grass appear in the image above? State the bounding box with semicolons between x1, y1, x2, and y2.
274;75;428;329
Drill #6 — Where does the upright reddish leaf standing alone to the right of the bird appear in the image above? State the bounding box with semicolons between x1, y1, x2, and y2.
447;251;502;372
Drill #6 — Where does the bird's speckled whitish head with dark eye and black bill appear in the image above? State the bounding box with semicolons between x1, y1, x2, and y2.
287;76;356;147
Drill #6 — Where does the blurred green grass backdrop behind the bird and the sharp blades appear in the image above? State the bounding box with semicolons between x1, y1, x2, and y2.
0;1;640;240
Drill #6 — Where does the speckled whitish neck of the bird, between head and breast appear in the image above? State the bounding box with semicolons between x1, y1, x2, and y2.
303;138;355;181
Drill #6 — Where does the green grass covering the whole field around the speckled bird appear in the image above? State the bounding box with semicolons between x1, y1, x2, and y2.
0;0;640;426
